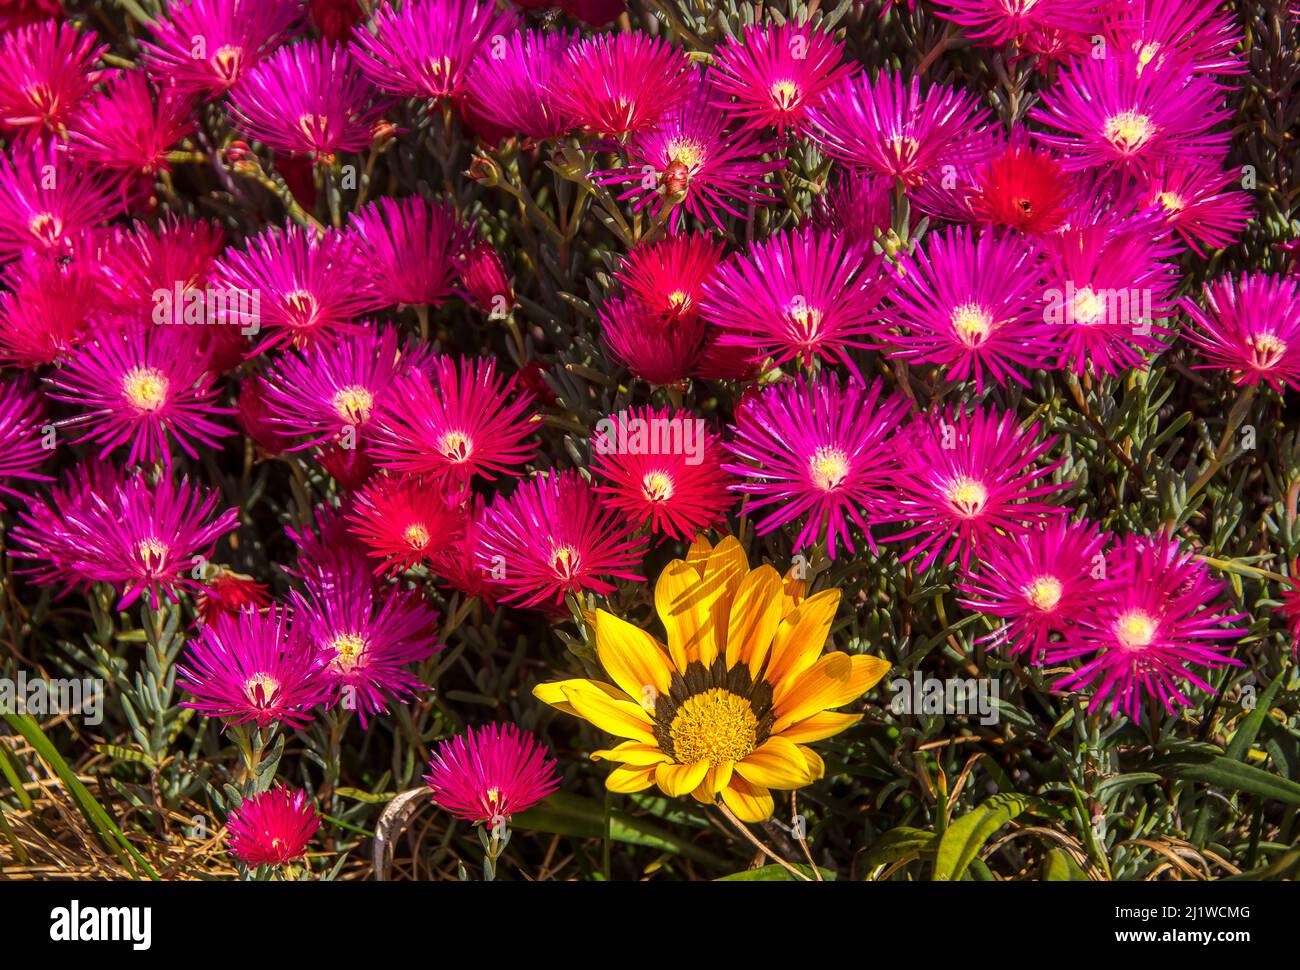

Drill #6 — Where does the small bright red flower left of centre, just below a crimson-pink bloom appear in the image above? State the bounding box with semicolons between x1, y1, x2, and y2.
347;476;462;575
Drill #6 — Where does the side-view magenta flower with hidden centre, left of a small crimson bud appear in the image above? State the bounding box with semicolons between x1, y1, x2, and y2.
350;195;472;307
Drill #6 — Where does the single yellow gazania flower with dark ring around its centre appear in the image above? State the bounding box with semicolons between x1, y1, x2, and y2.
533;536;889;822
